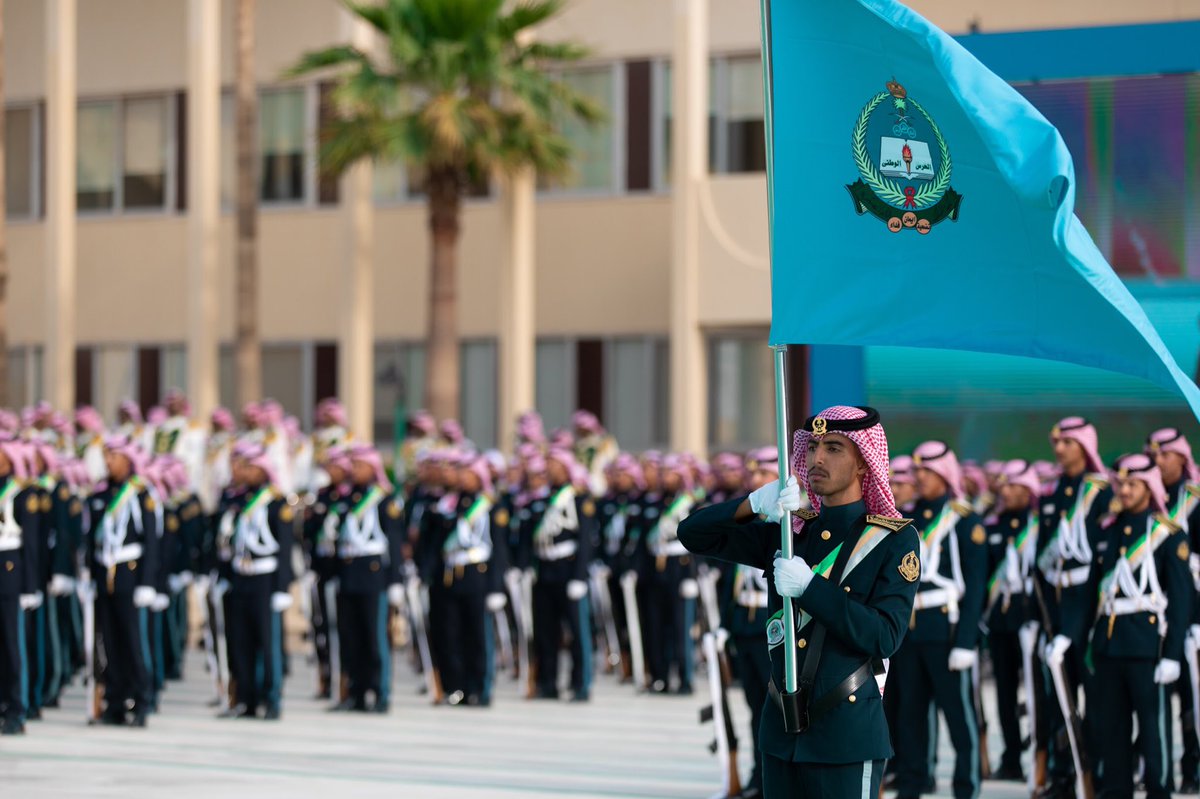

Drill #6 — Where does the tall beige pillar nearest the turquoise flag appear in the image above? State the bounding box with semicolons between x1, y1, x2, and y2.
671;0;708;455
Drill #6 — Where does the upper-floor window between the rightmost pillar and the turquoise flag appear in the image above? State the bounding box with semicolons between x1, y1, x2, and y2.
709;55;767;173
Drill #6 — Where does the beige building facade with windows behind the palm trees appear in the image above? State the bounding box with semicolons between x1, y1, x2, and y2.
4;0;1200;450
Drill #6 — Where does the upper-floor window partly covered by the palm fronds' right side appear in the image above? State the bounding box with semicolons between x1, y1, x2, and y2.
539;64;624;193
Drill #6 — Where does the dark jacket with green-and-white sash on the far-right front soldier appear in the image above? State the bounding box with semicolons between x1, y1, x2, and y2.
1087;510;1193;663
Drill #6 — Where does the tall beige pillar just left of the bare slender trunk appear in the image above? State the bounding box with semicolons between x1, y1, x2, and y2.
187;0;221;419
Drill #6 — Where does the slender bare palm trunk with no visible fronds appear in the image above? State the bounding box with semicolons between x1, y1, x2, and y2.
234;0;263;405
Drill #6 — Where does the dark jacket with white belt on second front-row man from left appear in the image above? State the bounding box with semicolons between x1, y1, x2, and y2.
86;482;160;594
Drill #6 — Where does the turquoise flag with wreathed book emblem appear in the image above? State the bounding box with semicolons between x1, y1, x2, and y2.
762;0;1200;416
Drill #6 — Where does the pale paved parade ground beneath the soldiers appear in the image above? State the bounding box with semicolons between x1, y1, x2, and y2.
0;659;1185;799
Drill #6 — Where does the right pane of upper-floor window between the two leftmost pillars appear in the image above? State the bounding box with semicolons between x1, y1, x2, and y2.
121;97;170;210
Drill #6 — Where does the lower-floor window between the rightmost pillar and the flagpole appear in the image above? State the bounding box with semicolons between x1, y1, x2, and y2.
708;331;775;450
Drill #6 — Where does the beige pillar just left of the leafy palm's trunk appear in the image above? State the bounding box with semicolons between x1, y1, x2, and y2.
337;11;374;440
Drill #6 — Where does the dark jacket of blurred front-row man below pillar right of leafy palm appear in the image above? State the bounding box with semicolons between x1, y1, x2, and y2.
517;486;599;583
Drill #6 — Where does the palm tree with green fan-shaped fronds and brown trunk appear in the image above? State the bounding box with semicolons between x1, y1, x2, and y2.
289;0;600;419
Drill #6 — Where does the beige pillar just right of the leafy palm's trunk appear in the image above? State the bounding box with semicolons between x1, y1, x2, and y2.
499;168;536;452
